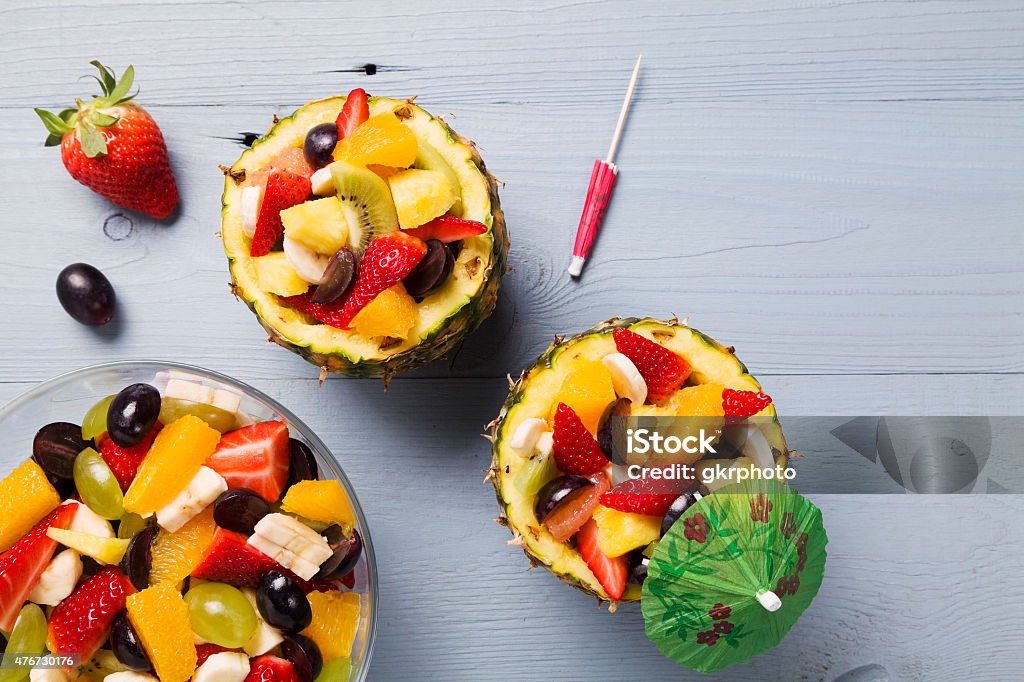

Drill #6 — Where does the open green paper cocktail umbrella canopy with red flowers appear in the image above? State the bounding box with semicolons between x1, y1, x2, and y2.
641;481;828;673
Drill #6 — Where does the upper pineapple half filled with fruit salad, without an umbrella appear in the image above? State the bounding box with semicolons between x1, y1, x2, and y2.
221;90;509;379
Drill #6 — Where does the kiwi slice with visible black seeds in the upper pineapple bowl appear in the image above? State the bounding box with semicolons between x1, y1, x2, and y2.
331;161;398;251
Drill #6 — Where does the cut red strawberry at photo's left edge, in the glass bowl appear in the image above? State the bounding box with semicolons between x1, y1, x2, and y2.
0;502;78;632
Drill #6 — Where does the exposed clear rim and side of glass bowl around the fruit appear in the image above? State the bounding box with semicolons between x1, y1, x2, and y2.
0;360;378;681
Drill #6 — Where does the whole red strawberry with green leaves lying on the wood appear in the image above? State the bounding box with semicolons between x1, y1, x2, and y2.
36;61;178;220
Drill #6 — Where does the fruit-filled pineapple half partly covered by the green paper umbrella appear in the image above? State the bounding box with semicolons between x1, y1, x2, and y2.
489;317;790;608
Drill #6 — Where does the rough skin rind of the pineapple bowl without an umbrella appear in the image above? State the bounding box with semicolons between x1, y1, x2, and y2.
221;97;510;376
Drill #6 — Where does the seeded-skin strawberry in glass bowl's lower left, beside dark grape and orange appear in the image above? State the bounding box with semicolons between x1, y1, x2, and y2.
46;566;135;660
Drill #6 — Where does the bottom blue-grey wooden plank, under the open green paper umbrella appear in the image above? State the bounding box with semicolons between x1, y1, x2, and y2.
0;376;1024;682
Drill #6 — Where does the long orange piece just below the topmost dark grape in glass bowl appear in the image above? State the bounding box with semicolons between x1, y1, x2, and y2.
125;415;220;515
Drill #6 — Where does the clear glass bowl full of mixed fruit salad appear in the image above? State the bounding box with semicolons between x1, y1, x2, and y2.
0;361;377;682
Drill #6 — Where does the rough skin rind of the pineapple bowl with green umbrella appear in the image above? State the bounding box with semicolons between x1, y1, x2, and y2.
484;317;792;610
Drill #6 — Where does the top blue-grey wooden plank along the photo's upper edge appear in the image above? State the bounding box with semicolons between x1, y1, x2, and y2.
8;0;1024;110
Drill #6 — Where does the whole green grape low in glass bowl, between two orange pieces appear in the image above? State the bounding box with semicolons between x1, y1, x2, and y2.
185;583;259;649
